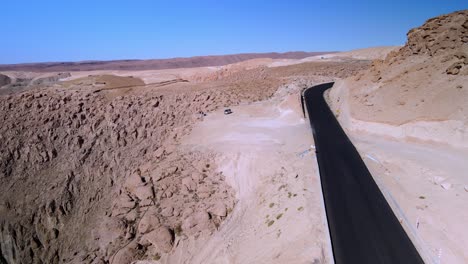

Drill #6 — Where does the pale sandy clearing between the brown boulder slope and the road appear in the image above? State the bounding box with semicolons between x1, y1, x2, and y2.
172;92;331;263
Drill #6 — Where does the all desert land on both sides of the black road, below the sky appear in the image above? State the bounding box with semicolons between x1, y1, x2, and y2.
0;11;468;264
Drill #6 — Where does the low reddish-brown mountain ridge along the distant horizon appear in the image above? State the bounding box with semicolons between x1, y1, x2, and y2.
0;51;333;72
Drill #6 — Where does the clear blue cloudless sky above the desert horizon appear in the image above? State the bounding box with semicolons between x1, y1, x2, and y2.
0;0;468;64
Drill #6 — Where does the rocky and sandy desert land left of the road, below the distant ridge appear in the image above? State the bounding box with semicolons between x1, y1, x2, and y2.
0;50;370;263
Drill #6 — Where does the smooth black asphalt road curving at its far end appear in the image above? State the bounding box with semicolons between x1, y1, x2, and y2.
303;83;424;264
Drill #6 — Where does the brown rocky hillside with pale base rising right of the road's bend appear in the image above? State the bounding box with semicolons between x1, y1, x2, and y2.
331;10;468;147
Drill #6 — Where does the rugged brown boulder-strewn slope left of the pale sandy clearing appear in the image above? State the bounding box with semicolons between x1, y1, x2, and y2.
0;86;241;263
